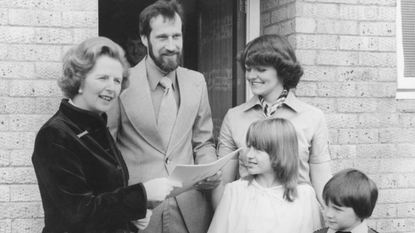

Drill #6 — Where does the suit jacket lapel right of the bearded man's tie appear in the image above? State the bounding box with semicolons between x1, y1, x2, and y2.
167;67;200;156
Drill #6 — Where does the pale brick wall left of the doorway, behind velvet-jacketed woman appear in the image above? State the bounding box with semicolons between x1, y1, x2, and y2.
0;0;98;233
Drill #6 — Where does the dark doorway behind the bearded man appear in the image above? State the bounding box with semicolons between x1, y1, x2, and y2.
98;0;246;141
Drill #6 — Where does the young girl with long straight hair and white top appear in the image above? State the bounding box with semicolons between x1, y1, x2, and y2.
208;118;324;233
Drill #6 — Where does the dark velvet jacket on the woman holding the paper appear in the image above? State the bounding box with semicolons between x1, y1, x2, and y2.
32;99;147;233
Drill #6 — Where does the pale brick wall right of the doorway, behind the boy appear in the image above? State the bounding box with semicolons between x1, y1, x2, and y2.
261;0;415;233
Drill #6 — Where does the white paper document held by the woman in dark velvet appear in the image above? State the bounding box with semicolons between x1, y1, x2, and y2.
167;148;242;197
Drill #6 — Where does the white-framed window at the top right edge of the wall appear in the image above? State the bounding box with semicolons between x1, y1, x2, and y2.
396;0;415;99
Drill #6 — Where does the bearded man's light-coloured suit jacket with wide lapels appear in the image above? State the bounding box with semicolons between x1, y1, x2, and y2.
108;59;216;233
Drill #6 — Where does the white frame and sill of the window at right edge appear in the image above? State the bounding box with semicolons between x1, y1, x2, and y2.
396;0;415;99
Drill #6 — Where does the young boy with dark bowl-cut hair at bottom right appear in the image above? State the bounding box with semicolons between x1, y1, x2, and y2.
315;169;378;233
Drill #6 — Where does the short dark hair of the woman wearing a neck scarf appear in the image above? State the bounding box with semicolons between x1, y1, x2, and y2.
237;34;303;88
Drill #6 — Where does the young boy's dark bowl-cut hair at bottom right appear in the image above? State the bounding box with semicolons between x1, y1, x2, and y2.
323;169;378;220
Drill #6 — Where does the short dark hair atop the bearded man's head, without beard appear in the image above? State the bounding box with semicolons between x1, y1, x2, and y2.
140;0;185;38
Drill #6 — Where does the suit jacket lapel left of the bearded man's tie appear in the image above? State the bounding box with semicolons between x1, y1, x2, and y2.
120;59;165;153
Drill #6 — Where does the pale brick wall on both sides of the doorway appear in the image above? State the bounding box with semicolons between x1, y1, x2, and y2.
0;0;415;233
